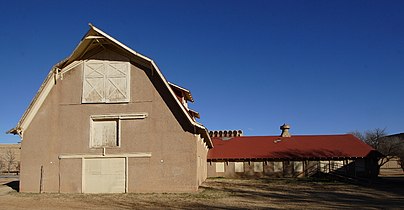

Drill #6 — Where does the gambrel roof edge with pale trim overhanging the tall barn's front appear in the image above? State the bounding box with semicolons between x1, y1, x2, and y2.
7;24;213;148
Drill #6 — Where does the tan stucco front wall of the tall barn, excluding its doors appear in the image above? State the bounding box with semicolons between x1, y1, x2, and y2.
20;48;207;192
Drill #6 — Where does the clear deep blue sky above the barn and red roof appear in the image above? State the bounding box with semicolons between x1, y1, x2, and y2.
0;0;404;143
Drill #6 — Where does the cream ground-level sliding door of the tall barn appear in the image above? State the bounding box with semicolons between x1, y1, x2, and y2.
83;158;126;193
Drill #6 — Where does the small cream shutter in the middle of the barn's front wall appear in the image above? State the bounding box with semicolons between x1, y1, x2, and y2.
90;119;119;148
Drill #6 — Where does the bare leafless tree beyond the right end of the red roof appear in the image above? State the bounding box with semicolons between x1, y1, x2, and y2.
351;128;404;167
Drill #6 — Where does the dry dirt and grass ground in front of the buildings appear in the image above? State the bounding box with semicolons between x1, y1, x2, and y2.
0;176;404;210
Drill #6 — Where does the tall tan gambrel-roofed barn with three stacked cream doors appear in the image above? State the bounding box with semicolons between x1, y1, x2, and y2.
9;24;213;193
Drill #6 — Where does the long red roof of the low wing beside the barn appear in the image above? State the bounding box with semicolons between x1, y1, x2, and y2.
208;134;375;160
